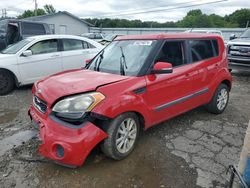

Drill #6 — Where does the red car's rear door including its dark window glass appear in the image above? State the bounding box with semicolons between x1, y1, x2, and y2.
188;39;219;105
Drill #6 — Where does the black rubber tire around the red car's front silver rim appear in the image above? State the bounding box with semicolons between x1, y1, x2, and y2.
101;112;140;160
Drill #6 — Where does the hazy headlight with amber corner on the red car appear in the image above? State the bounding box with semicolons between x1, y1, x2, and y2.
52;92;105;119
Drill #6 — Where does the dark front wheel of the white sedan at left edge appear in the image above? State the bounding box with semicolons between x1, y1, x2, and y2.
0;70;15;95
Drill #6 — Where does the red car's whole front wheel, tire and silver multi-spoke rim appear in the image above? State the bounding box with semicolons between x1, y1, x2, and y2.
101;113;139;160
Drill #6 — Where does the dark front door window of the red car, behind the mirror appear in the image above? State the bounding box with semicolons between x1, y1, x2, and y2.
157;41;185;67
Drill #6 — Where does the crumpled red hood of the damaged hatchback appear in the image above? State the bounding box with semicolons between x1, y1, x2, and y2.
35;69;128;105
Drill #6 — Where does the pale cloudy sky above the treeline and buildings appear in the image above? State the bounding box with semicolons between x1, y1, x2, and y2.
0;0;250;22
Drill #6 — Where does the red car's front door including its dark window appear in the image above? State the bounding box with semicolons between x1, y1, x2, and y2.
146;41;197;124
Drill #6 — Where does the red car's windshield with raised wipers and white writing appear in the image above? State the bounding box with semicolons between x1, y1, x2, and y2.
88;40;156;76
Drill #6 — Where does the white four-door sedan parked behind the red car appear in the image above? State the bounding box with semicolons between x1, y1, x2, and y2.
0;35;103;95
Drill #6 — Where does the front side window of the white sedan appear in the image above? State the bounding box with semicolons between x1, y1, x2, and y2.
29;39;58;55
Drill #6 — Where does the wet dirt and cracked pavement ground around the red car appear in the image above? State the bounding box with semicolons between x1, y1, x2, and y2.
0;73;250;188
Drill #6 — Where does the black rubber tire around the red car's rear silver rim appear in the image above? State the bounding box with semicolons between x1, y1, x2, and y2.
206;84;229;114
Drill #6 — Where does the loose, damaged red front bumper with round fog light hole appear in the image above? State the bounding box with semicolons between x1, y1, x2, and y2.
29;106;108;167
